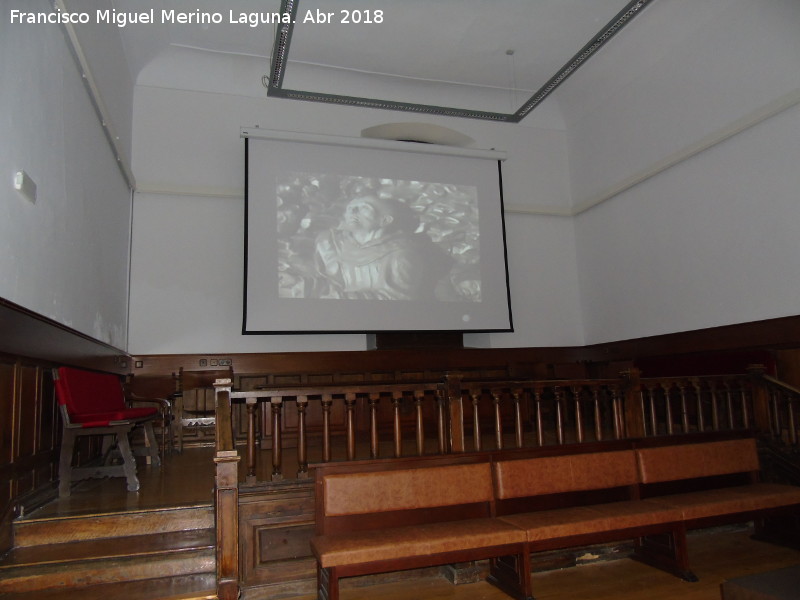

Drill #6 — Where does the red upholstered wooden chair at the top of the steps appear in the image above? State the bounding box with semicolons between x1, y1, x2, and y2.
54;367;161;497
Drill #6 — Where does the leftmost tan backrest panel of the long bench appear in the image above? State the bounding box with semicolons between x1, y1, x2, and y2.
316;461;493;533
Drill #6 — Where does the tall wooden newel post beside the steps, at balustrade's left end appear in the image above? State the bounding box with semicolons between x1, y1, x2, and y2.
214;379;240;600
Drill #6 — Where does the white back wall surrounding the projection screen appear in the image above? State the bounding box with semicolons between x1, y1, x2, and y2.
130;80;582;354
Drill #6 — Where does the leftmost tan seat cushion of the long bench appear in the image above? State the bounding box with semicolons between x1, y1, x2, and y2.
311;518;525;568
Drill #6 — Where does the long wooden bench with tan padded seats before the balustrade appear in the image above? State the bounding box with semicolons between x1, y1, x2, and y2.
312;438;800;600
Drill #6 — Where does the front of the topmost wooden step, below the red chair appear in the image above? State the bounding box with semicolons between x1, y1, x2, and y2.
14;504;214;548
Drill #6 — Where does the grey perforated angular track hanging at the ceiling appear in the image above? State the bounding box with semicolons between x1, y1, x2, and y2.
267;0;655;123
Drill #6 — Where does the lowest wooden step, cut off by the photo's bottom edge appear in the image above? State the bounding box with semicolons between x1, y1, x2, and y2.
0;573;217;600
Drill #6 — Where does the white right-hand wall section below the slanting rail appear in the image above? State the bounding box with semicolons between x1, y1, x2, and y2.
576;106;800;343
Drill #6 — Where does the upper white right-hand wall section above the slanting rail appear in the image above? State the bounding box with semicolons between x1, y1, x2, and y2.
559;0;800;213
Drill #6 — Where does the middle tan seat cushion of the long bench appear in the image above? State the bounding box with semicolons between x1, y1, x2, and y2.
500;500;680;542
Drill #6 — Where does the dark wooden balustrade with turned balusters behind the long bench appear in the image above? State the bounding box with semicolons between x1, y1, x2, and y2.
211;371;768;492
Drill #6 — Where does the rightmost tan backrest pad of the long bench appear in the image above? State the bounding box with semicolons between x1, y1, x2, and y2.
636;438;760;484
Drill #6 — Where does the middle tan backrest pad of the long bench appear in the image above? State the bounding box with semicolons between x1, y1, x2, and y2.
494;450;638;512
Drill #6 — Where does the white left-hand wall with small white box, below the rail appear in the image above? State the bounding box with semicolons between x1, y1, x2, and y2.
0;0;130;349
